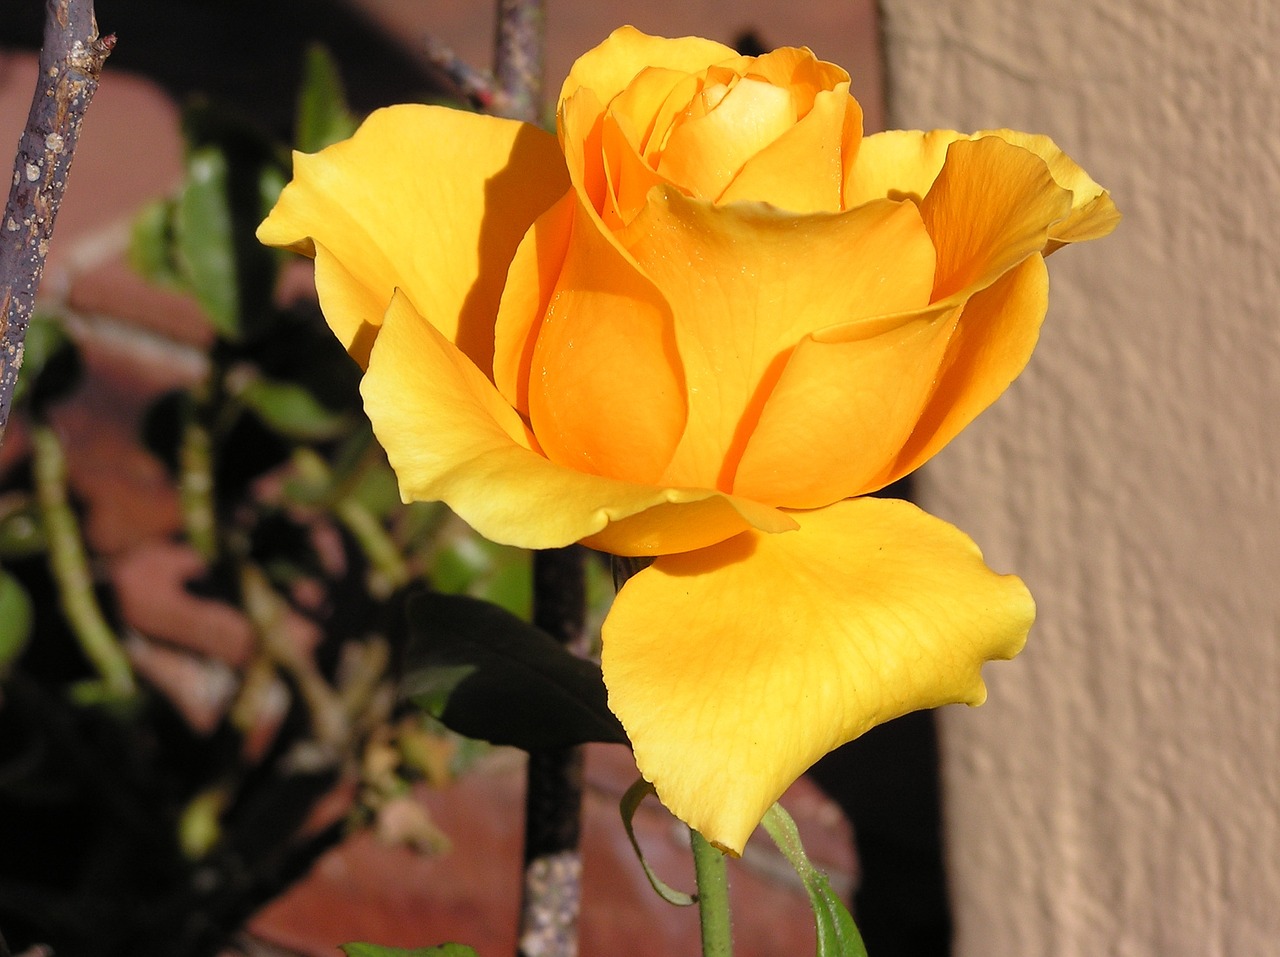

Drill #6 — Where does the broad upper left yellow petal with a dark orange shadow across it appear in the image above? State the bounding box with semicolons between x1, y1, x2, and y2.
257;105;568;374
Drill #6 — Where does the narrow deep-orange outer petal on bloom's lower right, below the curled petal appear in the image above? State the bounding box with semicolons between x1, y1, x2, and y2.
873;256;1048;487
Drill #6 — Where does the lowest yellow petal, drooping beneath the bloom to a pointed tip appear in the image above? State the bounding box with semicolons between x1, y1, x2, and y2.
603;498;1034;853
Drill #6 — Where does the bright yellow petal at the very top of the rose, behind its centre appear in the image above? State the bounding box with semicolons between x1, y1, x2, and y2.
559;27;737;118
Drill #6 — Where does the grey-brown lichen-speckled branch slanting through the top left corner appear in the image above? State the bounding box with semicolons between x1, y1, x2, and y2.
0;0;115;443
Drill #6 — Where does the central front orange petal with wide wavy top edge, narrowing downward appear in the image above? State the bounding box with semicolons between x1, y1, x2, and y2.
620;187;934;493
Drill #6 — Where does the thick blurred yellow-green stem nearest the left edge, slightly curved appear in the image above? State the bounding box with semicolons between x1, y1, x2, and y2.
31;422;137;699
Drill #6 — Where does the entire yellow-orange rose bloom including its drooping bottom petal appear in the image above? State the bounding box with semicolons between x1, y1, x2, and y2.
259;28;1119;853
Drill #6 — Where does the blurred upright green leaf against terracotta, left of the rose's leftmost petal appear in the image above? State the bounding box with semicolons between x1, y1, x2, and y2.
173;146;241;339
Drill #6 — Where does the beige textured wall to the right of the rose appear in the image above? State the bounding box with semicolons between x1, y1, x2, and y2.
883;0;1280;957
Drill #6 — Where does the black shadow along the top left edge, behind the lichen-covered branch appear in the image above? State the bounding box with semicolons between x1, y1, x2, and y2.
0;0;461;139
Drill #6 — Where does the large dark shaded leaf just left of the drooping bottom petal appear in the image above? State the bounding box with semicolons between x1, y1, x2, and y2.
401;592;627;751
